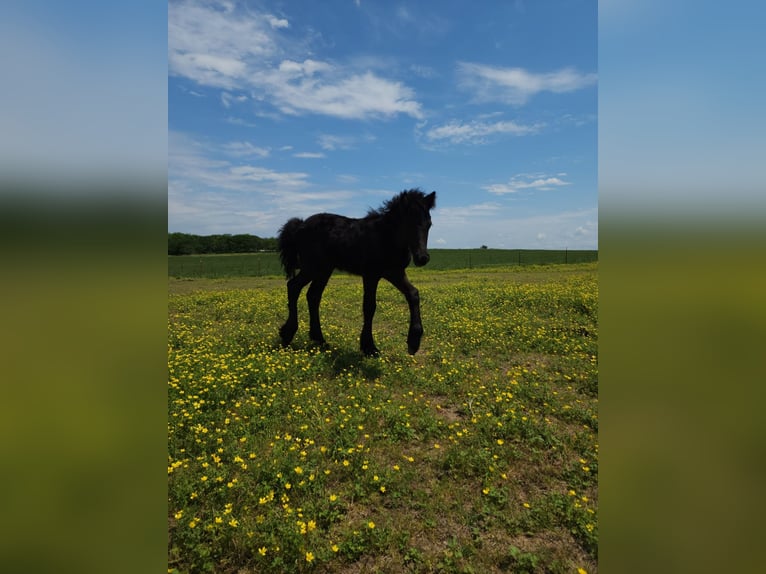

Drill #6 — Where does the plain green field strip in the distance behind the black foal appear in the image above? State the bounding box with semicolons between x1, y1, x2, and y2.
168;249;598;277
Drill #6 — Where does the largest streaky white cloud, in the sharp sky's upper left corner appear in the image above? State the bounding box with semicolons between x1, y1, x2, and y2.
168;0;423;119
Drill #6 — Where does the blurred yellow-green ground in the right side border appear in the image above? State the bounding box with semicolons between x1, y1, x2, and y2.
599;218;766;573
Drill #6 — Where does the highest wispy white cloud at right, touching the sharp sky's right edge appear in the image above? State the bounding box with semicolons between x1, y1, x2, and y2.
458;62;597;105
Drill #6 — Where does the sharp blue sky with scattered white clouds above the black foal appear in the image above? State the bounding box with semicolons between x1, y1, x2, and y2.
168;0;598;249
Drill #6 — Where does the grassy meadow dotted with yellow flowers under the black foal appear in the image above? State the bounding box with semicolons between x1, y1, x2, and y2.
168;263;598;574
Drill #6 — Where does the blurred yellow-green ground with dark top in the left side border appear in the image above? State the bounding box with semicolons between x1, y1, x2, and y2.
0;190;167;574
